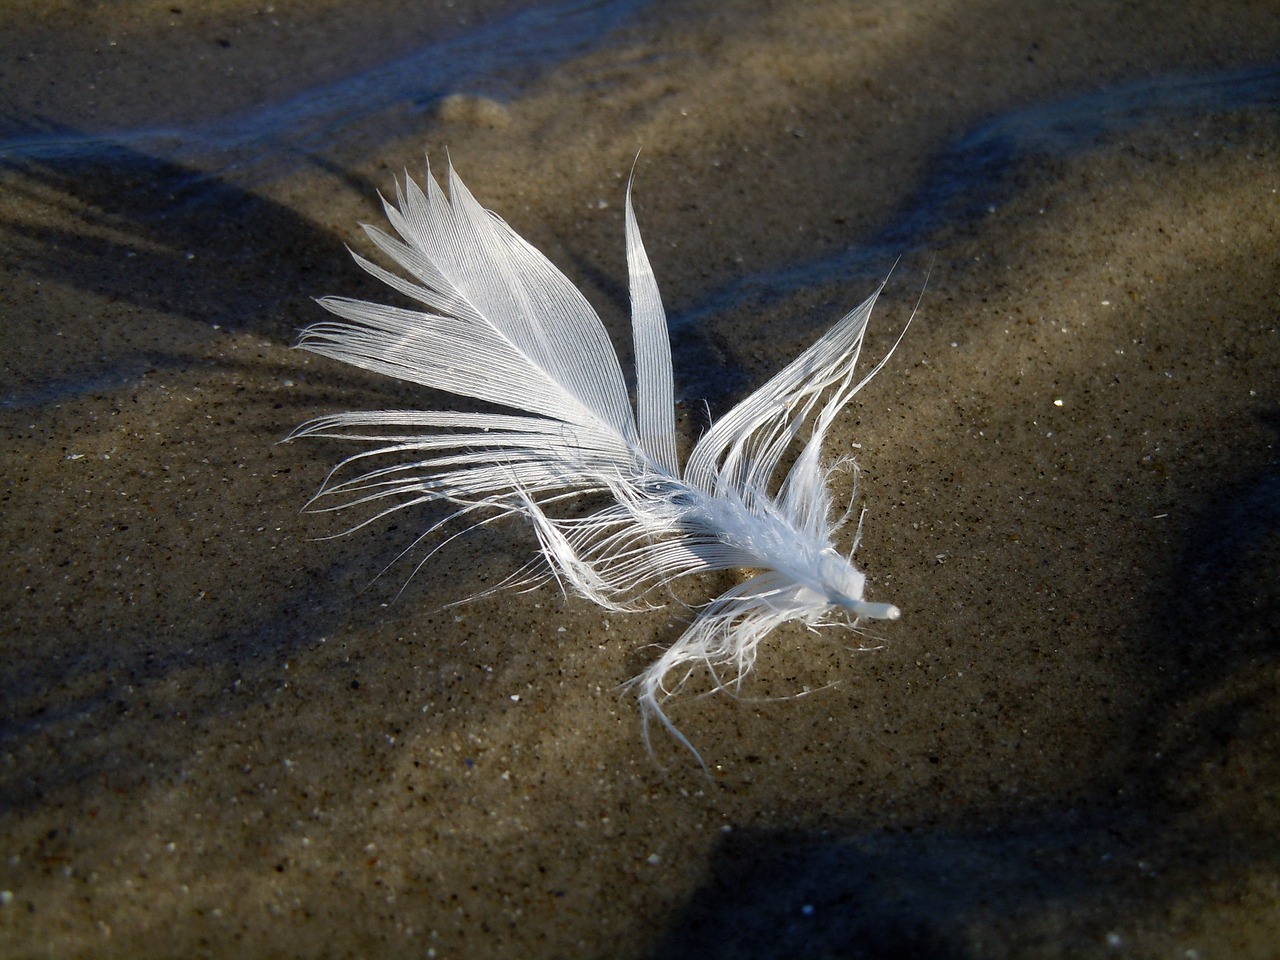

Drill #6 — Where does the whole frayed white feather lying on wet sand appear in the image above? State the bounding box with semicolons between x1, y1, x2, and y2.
289;165;899;749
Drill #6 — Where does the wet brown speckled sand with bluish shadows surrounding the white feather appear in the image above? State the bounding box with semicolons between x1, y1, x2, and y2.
0;0;1280;960
